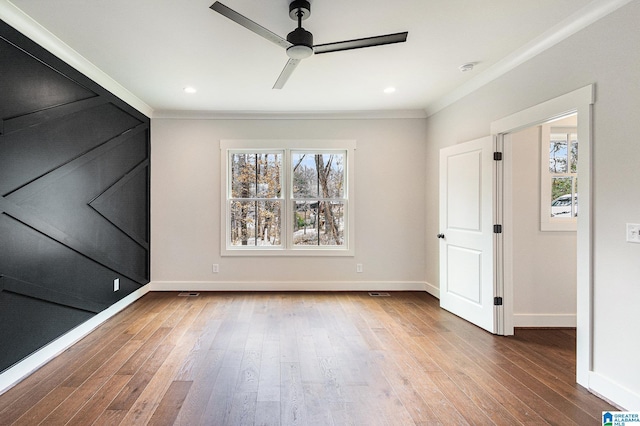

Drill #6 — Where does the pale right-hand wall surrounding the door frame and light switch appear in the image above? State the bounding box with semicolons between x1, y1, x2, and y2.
426;0;640;410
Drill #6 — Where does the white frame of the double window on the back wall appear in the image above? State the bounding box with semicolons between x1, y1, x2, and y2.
220;139;356;256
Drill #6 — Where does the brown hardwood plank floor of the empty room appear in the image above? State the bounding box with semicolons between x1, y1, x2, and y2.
0;292;615;425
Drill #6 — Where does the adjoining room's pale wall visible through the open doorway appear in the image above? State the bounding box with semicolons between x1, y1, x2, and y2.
505;126;577;327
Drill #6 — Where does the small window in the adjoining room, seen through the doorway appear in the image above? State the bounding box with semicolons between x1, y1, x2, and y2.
540;125;578;231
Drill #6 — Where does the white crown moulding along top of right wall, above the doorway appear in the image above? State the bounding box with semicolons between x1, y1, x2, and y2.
425;0;633;116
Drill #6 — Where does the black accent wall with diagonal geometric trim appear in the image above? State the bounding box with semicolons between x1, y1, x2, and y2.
0;21;150;371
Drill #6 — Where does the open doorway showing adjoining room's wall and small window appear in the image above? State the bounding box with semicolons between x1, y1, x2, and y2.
504;114;579;328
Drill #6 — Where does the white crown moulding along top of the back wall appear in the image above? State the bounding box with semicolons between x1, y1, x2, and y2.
153;109;427;120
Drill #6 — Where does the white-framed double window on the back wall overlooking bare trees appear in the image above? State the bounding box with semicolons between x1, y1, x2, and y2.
220;141;355;256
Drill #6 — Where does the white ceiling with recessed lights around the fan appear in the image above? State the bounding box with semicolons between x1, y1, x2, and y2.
2;0;603;112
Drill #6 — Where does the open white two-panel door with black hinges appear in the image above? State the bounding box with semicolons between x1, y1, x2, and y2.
438;136;497;333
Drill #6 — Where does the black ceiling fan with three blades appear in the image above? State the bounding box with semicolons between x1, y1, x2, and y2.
210;0;408;89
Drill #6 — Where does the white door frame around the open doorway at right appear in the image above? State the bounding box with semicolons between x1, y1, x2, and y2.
491;84;595;388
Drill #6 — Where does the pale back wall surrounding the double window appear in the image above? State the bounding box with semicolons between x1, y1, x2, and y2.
151;118;426;290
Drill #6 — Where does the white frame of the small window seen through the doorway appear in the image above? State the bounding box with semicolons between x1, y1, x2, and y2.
540;123;580;232
